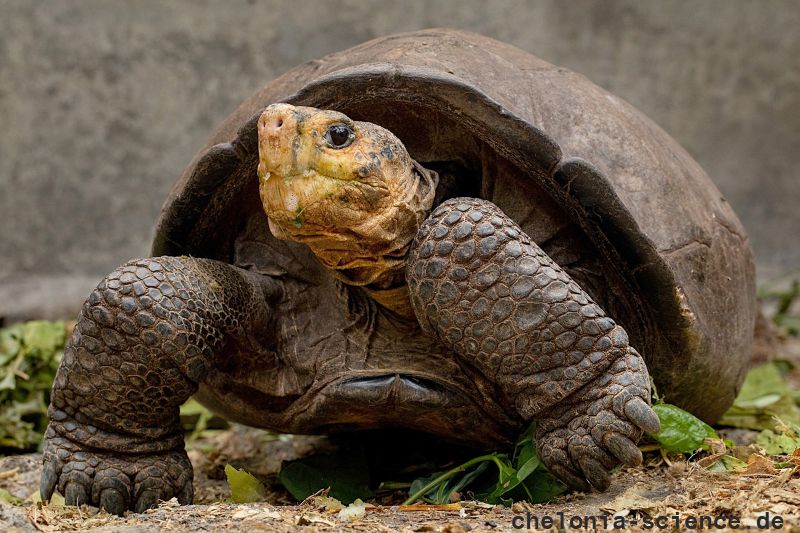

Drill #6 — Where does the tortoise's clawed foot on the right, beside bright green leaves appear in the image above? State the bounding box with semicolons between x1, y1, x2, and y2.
536;347;659;491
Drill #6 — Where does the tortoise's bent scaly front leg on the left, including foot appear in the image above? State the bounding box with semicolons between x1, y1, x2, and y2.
41;257;277;514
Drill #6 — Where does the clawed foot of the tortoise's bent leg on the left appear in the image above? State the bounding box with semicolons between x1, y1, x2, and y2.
40;431;194;516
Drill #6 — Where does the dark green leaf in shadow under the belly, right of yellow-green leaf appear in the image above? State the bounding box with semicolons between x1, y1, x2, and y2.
278;450;374;505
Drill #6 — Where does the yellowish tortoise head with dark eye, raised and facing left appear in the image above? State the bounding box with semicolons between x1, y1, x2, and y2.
258;104;436;287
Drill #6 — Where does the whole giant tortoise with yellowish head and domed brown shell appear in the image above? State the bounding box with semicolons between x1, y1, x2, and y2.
41;29;756;513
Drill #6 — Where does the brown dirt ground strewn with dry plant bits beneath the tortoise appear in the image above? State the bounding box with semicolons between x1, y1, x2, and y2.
0;341;800;533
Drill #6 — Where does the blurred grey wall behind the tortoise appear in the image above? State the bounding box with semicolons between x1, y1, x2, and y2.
0;0;800;319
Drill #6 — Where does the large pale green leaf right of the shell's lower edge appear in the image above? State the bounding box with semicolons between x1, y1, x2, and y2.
719;362;800;430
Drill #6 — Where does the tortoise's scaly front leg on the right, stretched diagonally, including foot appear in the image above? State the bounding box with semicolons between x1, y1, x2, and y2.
407;198;659;490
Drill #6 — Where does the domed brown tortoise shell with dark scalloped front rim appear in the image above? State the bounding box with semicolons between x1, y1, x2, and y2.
152;29;756;422
